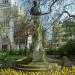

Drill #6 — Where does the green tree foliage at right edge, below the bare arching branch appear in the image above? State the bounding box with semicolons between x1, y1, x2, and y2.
63;19;75;40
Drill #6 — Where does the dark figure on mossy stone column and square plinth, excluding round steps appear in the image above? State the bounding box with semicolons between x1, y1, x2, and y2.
31;1;45;61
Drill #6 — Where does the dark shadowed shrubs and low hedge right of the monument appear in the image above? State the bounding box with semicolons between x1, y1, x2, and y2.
47;40;75;57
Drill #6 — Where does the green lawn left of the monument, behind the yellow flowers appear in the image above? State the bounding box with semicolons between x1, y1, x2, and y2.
0;55;26;67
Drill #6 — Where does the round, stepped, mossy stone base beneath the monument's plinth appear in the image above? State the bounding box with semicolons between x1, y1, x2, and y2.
15;62;60;72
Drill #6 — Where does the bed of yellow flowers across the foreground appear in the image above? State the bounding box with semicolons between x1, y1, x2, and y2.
0;67;75;75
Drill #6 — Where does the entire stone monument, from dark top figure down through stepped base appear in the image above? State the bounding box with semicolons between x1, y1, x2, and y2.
15;1;57;72
